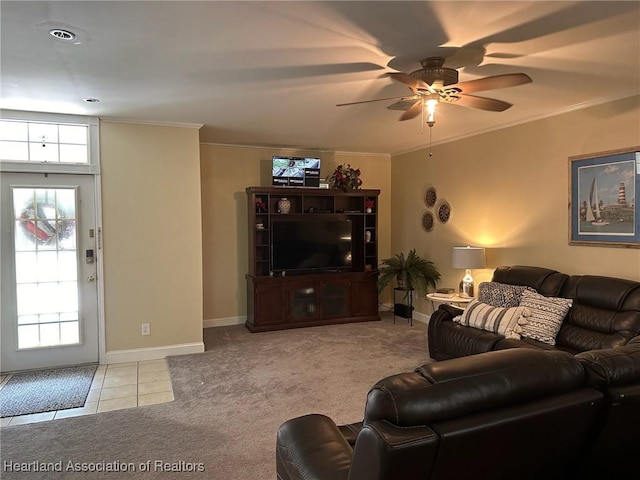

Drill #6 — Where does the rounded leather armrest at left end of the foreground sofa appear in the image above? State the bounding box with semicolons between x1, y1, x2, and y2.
276;414;353;480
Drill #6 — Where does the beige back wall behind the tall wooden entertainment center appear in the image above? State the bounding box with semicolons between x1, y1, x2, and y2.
200;144;391;325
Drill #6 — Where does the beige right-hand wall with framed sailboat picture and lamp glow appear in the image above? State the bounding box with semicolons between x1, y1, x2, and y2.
391;96;640;313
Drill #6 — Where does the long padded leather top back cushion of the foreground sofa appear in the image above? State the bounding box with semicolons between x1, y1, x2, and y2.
365;348;584;426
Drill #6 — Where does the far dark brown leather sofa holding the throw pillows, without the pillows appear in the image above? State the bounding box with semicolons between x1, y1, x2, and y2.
427;266;640;360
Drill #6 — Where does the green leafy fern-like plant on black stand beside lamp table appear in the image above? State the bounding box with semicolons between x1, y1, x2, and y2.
378;249;440;295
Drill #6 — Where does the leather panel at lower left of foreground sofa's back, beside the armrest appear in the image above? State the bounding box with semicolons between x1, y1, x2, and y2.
349;420;439;480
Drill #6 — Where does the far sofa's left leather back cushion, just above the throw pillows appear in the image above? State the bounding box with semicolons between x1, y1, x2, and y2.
493;265;569;297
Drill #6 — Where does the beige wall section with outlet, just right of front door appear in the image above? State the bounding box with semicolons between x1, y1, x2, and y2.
100;121;202;352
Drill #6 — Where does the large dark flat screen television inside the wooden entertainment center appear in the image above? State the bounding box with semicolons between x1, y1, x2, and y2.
271;217;352;273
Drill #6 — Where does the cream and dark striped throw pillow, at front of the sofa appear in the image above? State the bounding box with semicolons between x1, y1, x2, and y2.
453;299;525;340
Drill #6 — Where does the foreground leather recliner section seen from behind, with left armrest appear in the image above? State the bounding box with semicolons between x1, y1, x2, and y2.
276;349;604;480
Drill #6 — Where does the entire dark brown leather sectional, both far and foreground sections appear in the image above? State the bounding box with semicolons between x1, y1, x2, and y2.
276;266;640;480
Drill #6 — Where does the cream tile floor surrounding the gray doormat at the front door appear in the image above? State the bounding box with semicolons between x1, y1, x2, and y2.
0;359;173;427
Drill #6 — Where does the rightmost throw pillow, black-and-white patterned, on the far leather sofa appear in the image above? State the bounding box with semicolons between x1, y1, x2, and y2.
520;291;573;345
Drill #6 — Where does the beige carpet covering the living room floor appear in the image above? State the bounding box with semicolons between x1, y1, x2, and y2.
0;316;429;480
